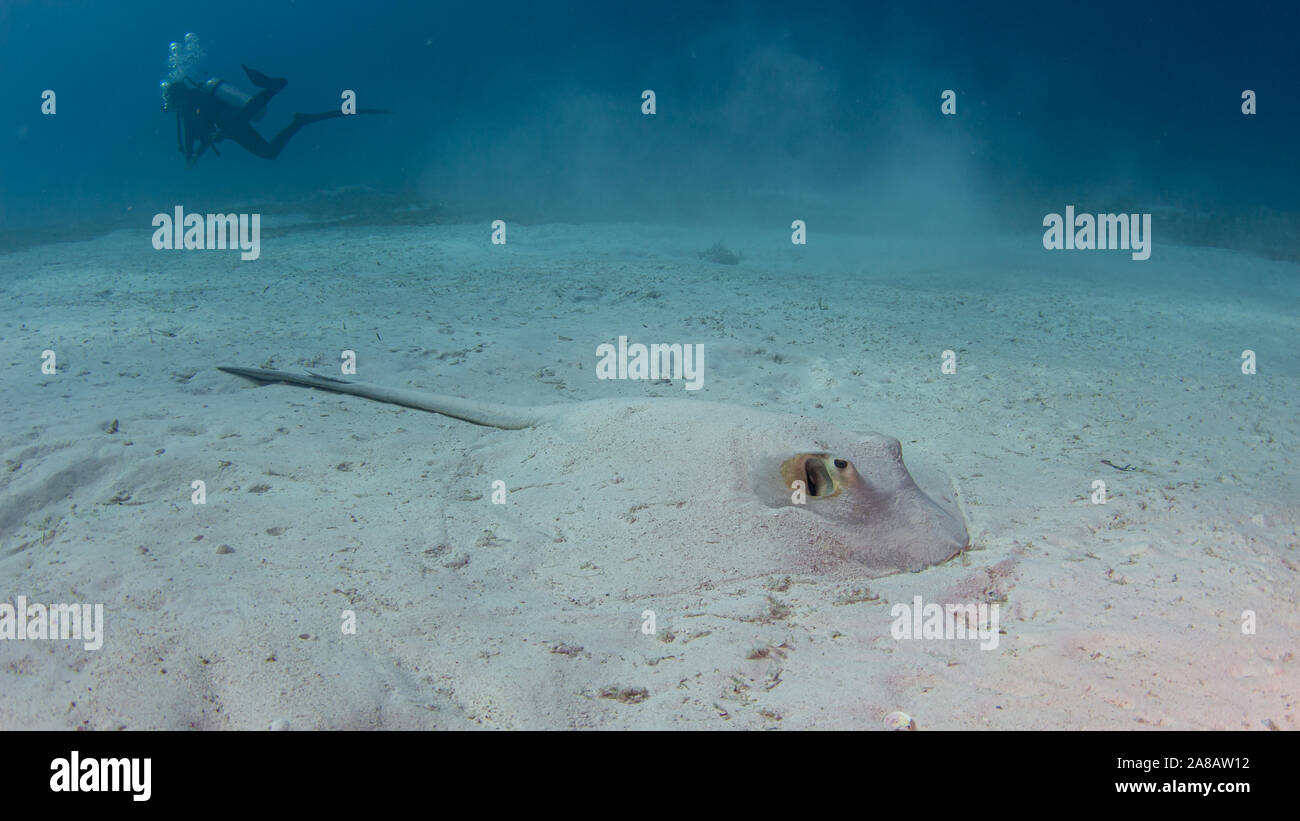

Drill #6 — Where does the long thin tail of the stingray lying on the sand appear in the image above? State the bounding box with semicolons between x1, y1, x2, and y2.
217;365;543;430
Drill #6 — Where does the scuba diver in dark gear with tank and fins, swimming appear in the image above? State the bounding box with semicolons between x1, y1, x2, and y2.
163;42;391;168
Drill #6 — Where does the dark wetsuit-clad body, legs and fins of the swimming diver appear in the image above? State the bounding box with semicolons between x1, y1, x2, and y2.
172;66;387;165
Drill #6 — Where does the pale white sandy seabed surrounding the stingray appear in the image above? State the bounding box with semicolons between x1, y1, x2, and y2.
0;221;1300;729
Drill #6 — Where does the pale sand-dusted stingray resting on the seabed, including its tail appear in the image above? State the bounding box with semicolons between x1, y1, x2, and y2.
220;368;970;591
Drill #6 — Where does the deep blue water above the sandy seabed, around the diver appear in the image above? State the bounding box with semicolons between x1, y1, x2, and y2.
0;0;1300;239
